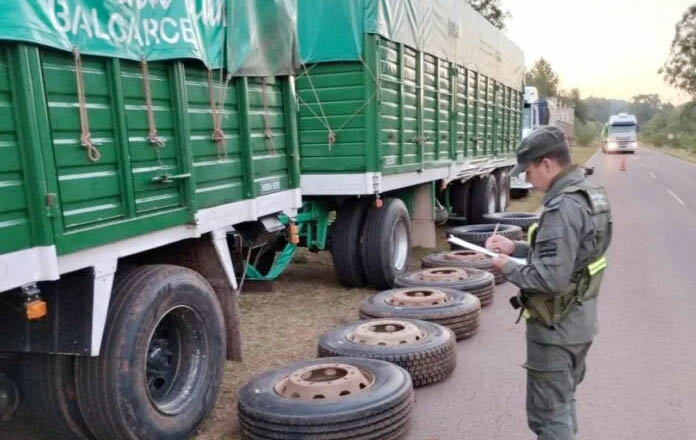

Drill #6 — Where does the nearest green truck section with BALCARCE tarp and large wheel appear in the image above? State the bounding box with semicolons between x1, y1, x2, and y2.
0;0;301;440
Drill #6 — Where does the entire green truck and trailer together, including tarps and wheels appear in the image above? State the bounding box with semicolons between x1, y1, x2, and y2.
0;0;524;440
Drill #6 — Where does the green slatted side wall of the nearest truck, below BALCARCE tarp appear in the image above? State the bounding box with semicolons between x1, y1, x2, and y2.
0;43;299;254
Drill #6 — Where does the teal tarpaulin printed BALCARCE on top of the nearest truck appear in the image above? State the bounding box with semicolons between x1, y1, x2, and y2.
0;0;298;76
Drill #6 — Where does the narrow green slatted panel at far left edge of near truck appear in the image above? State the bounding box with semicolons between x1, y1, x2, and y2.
0;46;32;254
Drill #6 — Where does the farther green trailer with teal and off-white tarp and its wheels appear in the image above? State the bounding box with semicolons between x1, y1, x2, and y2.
252;0;524;288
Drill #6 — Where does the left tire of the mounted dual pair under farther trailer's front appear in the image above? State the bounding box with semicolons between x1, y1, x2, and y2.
331;199;370;287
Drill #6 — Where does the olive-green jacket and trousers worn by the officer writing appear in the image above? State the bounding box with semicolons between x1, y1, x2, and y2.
503;167;611;440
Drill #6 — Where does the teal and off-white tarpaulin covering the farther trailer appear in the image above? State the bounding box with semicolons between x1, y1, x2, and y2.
297;0;524;89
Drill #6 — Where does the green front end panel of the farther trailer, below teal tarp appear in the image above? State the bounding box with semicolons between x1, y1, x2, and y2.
296;62;368;173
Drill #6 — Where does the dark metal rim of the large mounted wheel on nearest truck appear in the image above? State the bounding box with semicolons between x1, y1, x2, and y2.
145;306;208;415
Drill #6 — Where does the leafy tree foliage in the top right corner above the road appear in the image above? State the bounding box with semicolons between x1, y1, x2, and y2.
659;5;696;99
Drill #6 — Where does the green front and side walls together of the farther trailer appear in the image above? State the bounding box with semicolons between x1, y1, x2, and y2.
297;35;521;179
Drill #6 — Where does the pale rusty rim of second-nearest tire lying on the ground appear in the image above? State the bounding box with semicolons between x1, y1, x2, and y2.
348;319;427;347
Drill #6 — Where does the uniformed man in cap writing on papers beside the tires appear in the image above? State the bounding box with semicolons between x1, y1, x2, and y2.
486;127;611;440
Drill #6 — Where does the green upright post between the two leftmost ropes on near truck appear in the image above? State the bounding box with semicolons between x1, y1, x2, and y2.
107;58;136;218
